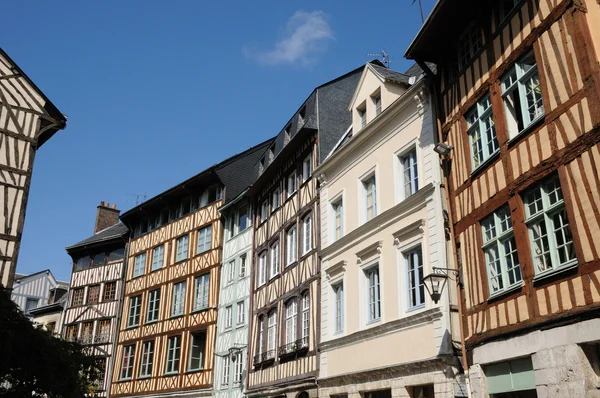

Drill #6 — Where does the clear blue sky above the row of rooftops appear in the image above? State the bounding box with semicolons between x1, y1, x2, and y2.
1;0;434;280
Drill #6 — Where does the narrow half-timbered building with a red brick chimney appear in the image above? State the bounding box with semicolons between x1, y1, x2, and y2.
62;202;128;397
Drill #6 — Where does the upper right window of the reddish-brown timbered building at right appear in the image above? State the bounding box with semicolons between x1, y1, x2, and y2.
502;51;544;138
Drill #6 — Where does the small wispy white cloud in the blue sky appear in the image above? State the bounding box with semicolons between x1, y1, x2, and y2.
244;11;333;66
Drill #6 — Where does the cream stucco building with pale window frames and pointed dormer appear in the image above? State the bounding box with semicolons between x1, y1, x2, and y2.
315;65;458;397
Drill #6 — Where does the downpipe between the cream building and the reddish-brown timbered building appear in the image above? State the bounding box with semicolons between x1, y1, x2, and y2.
415;59;471;398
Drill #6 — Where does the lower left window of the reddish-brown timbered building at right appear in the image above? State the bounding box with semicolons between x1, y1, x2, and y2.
481;206;523;295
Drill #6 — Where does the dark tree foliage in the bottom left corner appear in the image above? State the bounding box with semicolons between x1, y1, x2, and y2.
0;286;100;398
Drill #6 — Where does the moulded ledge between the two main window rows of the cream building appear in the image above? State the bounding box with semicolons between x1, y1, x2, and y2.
319;183;435;259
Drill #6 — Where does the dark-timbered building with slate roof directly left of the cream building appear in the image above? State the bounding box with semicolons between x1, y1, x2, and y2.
247;62;362;397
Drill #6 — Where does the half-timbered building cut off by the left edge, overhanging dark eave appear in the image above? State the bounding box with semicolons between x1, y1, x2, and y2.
0;48;66;288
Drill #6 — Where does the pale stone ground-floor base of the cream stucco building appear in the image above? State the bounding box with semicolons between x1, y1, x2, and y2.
319;358;467;398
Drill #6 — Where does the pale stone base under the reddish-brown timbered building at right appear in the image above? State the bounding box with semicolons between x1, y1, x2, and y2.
469;319;600;398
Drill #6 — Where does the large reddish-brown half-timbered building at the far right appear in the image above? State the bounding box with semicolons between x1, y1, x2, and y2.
406;0;600;397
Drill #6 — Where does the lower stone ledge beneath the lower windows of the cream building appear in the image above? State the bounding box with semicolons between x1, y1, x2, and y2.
319;307;442;352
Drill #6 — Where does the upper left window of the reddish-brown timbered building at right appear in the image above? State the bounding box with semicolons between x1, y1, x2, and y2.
465;94;499;170
